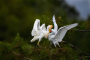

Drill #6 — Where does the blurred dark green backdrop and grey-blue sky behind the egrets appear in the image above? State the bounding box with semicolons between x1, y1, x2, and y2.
0;0;90;59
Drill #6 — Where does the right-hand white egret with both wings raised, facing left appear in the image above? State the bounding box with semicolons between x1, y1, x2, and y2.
48;15;78;47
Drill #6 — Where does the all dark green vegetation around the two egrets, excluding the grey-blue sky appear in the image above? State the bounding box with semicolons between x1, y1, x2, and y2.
0;0;90;60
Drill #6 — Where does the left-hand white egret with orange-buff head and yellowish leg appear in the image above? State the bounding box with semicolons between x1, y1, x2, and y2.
30;19;53;46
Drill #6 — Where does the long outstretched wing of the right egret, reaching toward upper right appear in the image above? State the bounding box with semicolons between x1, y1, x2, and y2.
53;23;78;43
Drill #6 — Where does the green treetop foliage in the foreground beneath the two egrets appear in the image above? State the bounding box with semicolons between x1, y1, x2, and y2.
0;33;89;60
